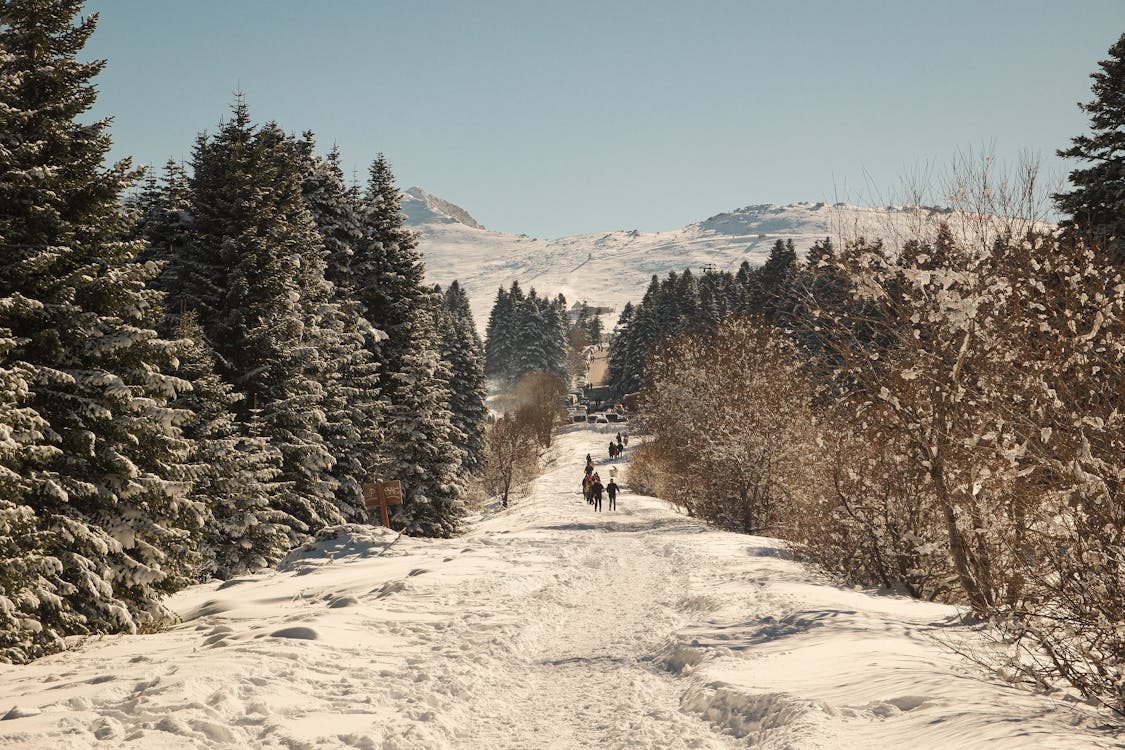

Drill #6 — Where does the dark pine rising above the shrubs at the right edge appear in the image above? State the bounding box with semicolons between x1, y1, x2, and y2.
1054;34;1125;265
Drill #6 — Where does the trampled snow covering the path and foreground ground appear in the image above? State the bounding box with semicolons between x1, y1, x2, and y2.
0;425;1121;750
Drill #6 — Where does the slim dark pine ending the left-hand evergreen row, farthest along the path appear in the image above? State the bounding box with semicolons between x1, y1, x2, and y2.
441;281;488;473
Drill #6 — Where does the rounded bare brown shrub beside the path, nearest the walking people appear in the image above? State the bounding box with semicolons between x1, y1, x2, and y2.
645;319;816;534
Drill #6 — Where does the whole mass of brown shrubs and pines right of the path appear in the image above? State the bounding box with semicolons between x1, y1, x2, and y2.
625;36;1125;713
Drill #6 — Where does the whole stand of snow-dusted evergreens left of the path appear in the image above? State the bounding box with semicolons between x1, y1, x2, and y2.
0;0;486;661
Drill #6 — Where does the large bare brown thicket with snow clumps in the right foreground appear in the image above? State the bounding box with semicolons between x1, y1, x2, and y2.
794;159;1125;712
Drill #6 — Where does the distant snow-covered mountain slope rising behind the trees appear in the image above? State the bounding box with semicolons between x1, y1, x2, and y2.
403;193;949;329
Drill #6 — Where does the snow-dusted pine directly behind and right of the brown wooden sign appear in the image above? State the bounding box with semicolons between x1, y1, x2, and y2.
385;307;465;536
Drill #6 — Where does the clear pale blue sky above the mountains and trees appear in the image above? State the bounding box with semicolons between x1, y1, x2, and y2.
84;0;1125;237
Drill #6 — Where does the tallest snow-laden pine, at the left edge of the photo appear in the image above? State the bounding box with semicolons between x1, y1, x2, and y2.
0;0;203;653
